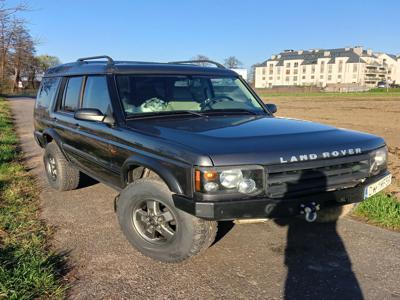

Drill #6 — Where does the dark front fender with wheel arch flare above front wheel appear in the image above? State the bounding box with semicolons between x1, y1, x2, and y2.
121;154;192;196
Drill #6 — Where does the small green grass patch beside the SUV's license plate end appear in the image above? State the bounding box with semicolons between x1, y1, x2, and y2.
353;193;400;230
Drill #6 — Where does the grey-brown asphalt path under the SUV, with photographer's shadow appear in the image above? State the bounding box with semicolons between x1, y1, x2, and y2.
7;98;400;299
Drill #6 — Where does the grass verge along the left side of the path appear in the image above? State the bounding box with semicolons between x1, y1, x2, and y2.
0;98;66;299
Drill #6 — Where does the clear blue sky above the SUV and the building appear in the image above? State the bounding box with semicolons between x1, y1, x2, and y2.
6;0;400;68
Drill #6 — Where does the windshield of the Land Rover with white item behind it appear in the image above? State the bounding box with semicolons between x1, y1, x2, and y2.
116;75;264;117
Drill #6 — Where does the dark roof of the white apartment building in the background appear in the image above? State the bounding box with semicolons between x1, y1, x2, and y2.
263;48;376;66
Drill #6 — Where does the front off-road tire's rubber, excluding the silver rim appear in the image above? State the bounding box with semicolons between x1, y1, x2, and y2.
117;178;217;262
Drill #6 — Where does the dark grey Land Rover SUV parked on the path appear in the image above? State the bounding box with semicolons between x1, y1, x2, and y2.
34;56;391;262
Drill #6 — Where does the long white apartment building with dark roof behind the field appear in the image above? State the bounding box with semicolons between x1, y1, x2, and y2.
255;47;400;88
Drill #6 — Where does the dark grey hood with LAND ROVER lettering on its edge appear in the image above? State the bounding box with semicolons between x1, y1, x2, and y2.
128;115;385;166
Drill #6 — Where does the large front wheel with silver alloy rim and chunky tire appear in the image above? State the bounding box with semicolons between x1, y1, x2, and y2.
117;179;217;262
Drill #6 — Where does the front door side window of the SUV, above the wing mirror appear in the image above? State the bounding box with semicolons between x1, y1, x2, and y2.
82;76;111;115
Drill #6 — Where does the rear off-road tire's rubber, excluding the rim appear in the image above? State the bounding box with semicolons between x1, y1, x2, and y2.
43;142;80;191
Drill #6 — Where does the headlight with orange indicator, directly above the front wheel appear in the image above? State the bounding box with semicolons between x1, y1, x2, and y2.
195;166;264;194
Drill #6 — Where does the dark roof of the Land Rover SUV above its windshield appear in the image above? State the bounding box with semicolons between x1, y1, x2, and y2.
45;59;237;77
